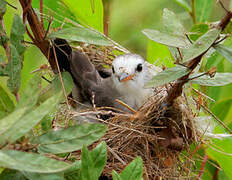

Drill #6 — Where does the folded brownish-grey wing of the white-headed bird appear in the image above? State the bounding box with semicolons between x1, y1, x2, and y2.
70;51;119;107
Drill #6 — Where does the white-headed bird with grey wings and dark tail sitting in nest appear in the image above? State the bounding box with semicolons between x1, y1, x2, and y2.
54;39;161;114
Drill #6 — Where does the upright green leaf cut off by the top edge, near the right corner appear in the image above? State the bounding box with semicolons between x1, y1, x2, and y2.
195;0;213;23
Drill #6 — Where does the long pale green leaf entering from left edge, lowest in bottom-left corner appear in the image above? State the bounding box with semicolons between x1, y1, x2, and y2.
0;150;70;173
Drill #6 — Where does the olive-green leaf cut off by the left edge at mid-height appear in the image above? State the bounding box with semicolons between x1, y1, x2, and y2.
0;84;15;118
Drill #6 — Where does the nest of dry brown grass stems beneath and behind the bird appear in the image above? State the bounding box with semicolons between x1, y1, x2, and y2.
73;46;200;179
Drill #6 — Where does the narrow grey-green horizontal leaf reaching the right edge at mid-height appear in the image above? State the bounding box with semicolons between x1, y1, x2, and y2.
190;73;232;86
